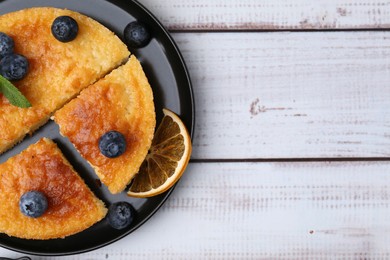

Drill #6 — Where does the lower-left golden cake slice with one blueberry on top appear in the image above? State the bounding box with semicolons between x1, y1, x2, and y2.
0;138;107;239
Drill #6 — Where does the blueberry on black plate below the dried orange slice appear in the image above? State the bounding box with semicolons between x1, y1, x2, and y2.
107;201;135;229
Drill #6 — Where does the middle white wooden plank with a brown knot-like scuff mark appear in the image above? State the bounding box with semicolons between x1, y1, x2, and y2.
173;31;390;159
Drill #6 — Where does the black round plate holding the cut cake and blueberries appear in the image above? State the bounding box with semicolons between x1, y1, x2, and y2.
0;0;194;255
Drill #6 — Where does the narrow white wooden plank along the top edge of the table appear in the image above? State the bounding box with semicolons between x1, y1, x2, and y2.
139;0;390;30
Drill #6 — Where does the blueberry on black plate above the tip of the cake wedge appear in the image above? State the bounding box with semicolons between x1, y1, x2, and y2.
124;22;150;48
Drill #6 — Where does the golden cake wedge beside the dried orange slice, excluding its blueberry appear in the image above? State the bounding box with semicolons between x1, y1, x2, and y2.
54;55;156;194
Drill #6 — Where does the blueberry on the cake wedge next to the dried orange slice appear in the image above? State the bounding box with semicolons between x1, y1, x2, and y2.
99;131;126;158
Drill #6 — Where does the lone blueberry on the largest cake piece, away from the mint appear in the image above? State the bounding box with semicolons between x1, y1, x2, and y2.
51;16;79;42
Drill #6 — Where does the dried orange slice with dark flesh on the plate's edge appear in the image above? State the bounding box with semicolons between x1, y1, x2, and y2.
127;109;192;198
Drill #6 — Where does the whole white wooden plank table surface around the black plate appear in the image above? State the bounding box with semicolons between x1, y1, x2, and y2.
0;0;390;260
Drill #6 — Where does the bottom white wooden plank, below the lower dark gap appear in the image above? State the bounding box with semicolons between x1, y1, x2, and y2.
0;162;390;260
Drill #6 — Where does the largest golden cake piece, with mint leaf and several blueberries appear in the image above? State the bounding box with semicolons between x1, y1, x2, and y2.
0;7;130;154
